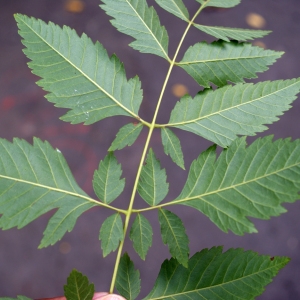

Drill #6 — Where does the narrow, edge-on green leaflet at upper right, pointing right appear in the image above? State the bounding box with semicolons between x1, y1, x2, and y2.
194;24;272;42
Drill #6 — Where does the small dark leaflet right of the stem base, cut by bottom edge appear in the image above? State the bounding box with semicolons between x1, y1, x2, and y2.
116;253;141;300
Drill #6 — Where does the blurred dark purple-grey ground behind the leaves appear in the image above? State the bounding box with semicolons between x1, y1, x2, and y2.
0;0;300;300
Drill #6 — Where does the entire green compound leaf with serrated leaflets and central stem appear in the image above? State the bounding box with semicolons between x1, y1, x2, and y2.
0;0;300;300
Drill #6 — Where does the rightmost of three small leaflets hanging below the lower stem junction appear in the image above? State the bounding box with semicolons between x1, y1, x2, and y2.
158;208;190;267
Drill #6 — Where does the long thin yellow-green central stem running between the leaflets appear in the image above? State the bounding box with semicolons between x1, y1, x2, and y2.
110;6;204;294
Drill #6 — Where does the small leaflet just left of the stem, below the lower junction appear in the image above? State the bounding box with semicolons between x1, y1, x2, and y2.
99;213;124;257
